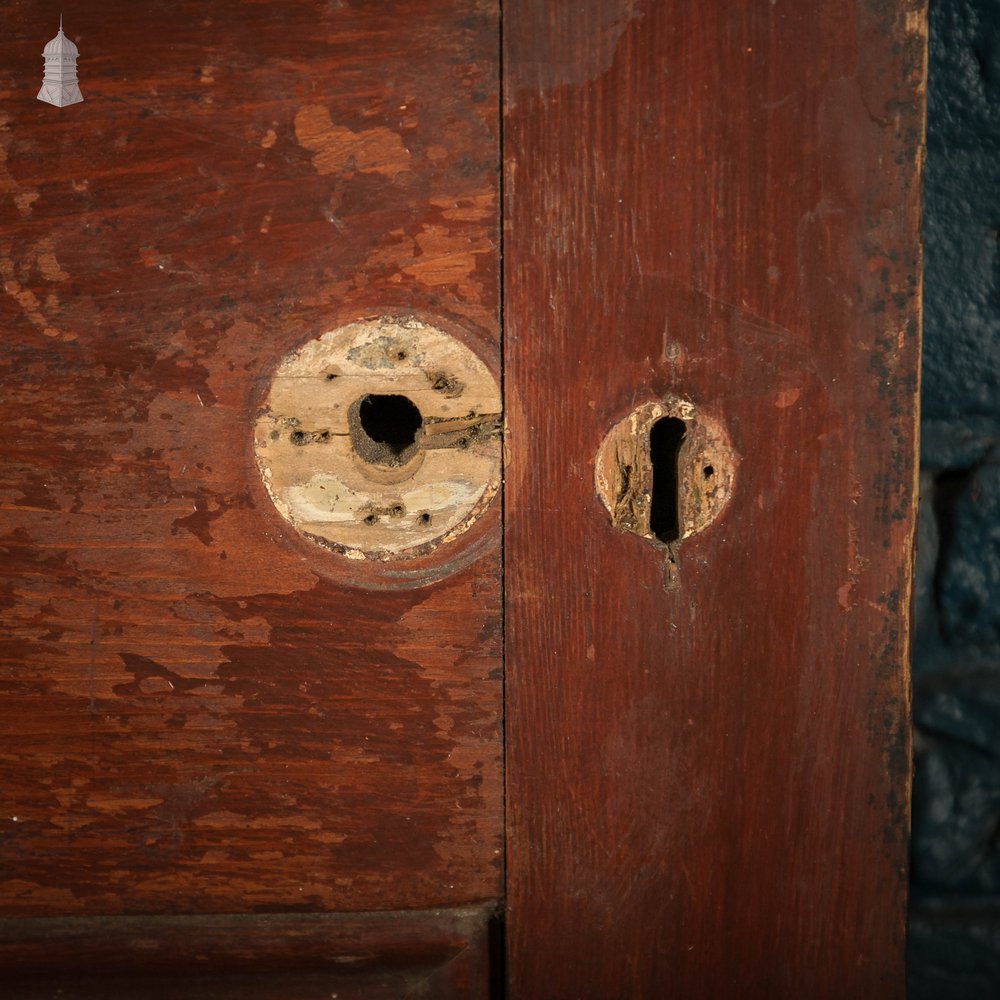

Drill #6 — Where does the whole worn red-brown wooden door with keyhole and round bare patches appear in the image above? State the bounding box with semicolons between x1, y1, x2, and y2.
0;0;924;998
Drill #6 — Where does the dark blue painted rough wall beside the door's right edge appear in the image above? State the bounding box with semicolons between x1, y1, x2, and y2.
909;0;1000;1000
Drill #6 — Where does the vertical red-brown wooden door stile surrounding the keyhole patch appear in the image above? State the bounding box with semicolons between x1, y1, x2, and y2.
504;0;925;998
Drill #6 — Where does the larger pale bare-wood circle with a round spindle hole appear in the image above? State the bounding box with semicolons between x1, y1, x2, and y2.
254;317;501;561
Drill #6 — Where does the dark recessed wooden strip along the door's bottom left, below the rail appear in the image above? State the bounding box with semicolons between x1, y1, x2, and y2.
0;908;492;1000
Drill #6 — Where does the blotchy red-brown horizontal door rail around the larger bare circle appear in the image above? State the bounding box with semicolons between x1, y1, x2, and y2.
0;0;502;916
